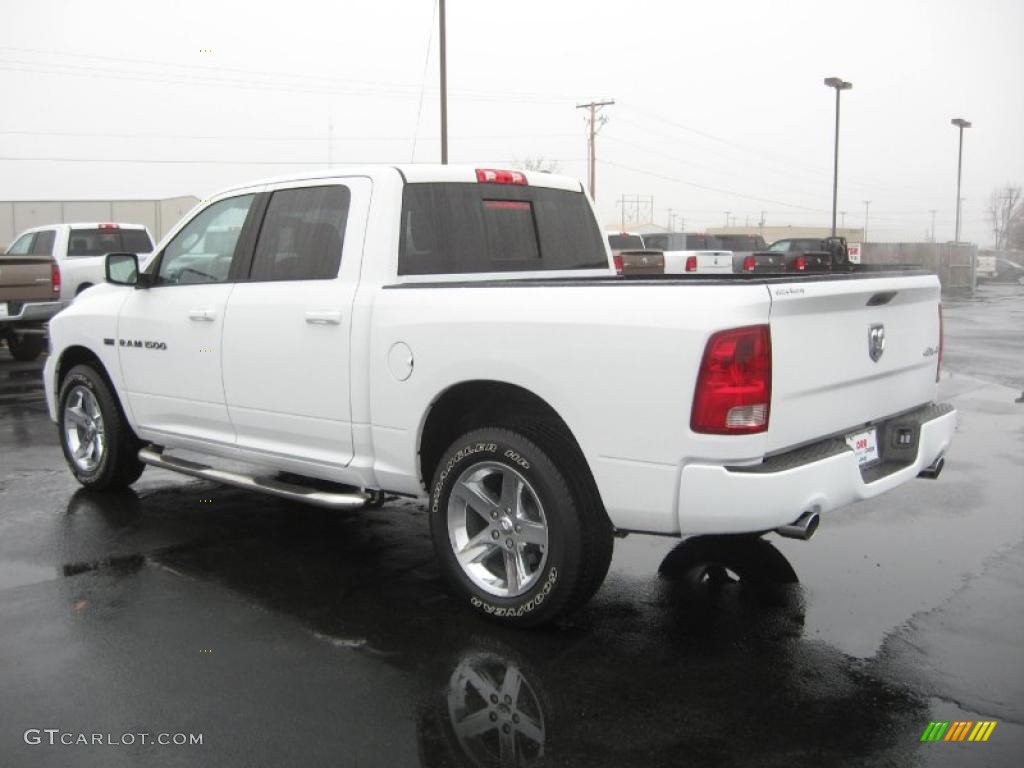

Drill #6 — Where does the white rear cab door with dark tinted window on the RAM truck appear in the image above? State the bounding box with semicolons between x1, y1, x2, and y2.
222;177;371;467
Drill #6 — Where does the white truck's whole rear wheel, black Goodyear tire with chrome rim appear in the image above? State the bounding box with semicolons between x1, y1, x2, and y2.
429;427;612;627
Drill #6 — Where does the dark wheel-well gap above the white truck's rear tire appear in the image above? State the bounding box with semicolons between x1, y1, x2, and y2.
417;379;606;528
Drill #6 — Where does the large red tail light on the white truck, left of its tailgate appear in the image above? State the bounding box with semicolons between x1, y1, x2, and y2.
690;326;771;434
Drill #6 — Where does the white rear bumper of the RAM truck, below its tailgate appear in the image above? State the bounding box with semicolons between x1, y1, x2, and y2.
679;403;956;535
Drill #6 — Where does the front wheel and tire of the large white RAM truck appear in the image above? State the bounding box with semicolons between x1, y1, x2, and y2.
57;365;145;490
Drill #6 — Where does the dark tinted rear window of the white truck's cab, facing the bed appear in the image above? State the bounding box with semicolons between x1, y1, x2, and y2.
398;182;608;275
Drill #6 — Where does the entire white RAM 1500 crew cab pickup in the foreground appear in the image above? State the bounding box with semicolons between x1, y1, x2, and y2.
37;165;955;625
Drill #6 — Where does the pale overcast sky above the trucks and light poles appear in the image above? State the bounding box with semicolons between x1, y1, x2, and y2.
0;0;1024;244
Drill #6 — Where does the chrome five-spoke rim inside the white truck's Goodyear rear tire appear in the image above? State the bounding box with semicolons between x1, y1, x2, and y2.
447;462;548;597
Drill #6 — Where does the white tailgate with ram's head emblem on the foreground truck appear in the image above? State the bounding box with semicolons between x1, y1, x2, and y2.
767;275;939;453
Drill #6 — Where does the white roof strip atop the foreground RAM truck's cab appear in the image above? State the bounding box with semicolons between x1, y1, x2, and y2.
214;163;583;197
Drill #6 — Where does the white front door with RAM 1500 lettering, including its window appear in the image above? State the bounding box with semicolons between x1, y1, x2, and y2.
115;194;256;444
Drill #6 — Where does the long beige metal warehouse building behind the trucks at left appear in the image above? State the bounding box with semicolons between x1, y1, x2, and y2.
0;195;199;252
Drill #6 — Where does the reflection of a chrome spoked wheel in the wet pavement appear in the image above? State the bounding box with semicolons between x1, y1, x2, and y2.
447;653;545;768
